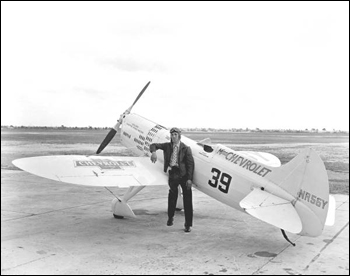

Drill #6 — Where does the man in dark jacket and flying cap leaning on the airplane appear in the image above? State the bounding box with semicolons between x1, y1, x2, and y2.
150;127;194;232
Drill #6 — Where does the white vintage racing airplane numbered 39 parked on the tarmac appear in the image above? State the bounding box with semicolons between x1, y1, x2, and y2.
13;82;335;245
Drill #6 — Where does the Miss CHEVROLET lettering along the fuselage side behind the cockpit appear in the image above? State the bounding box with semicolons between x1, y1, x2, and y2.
218;149;271;177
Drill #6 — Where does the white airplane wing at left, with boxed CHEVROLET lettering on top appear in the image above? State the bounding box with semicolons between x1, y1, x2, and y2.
12;155;168;188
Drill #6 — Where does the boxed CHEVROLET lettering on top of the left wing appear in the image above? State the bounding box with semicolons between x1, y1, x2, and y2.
73;158;136;170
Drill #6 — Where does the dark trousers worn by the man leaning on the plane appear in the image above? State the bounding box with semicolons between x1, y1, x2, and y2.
168;167;193;226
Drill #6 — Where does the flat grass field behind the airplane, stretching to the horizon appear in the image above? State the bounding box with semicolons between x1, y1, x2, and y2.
1;129;349;195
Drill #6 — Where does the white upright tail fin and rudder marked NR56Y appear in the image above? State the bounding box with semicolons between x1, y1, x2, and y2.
266;149;330;236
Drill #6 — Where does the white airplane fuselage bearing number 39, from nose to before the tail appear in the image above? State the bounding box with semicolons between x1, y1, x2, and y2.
120;114;280;211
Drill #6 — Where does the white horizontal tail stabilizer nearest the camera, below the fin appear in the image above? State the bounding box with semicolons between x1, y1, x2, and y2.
239;189;302;233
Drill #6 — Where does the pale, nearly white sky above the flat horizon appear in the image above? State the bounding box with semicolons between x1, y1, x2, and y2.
1;1;349;130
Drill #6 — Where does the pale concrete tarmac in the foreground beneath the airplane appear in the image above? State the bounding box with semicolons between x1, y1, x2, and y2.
1;130;349;275
